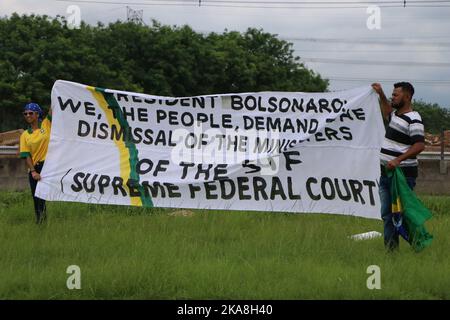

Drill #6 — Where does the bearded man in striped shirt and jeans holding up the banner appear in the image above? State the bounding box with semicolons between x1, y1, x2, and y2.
372;82;425;250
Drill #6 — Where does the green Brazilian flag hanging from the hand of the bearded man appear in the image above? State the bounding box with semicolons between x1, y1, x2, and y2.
386;167;433;252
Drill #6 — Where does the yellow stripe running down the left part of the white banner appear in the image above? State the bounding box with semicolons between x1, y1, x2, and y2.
86;86;142;207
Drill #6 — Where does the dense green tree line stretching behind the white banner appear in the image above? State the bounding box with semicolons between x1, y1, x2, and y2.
0;14;450;133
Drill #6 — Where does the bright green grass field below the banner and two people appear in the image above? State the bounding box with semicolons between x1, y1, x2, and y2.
0;192;450;299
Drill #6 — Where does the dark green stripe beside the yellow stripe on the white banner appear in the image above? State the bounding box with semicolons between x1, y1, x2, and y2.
95;87;153;207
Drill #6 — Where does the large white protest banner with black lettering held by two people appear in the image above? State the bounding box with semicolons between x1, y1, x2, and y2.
36;81;384;218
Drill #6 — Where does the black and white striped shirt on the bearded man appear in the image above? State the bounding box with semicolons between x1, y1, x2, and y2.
380;111;425;176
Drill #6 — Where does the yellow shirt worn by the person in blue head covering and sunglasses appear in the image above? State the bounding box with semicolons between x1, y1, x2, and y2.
20;115;52;165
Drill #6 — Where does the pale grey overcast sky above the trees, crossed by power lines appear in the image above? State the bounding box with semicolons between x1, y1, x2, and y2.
0;0;450;107
